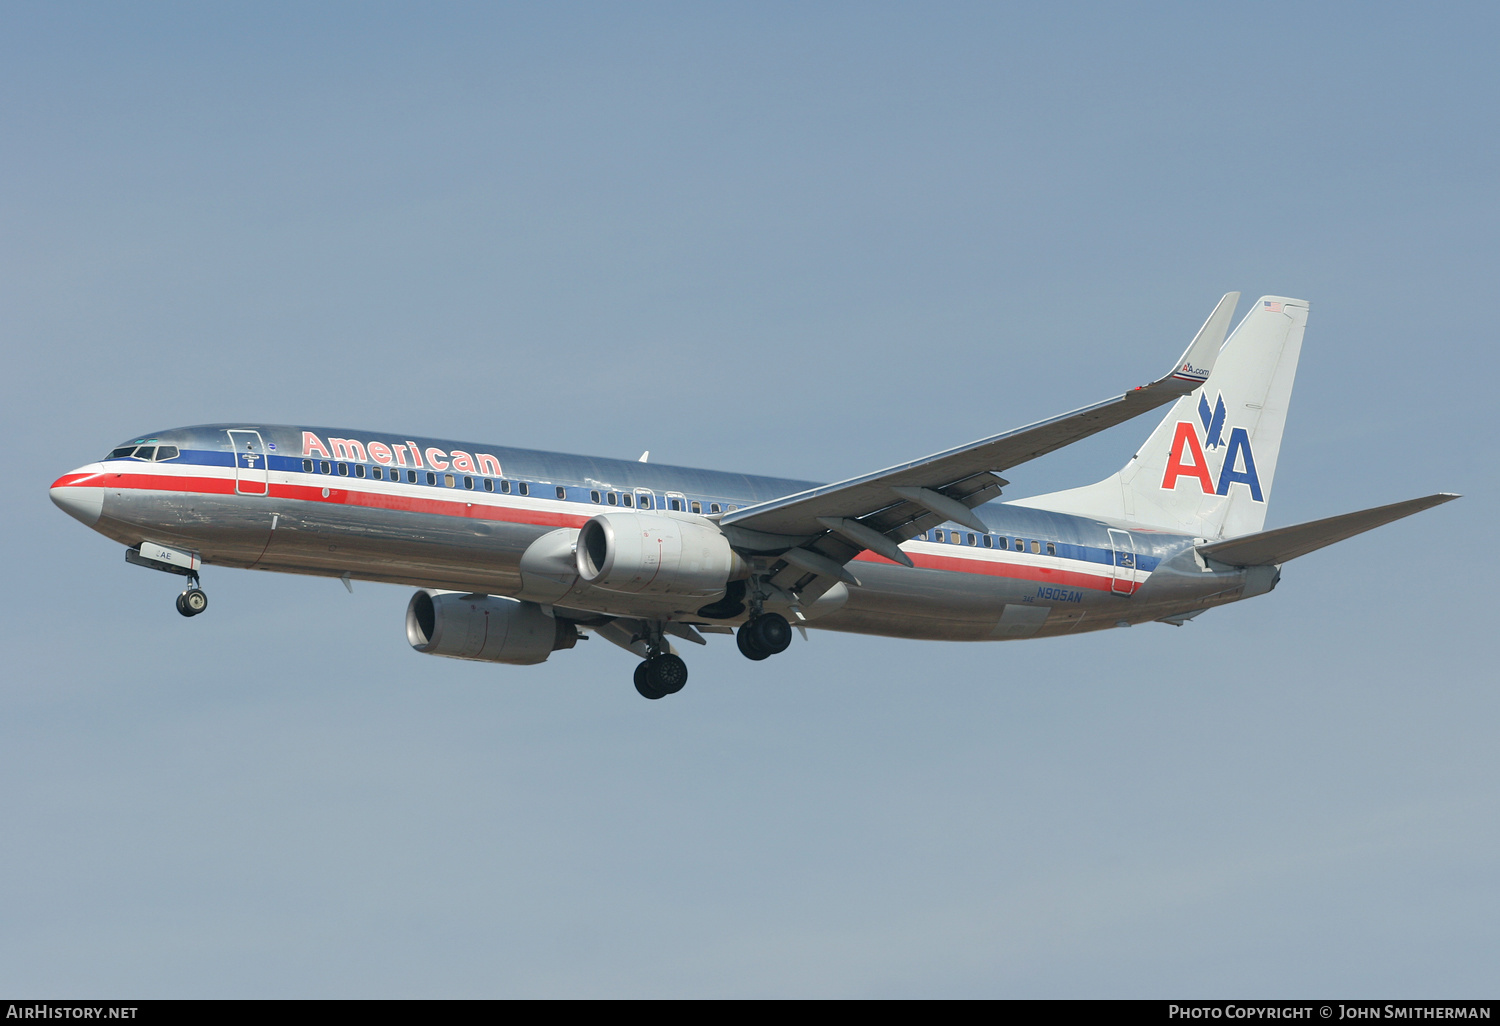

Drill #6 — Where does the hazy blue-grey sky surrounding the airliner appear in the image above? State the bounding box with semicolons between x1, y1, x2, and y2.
0;3;1500;998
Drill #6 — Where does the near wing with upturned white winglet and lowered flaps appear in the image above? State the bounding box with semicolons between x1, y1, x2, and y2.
720;293;1239;585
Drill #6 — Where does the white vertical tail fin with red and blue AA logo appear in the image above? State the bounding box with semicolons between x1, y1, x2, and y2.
1016;296;1308;539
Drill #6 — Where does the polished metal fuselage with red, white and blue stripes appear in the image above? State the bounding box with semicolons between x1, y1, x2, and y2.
54;425;1275;641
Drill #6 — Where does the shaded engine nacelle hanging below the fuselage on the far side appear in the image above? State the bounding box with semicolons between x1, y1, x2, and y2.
407;590;578;666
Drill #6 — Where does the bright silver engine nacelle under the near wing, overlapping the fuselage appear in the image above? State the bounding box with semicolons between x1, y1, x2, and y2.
575;513;750;599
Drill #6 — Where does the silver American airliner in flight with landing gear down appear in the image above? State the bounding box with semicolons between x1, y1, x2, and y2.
51;293;1458;699
